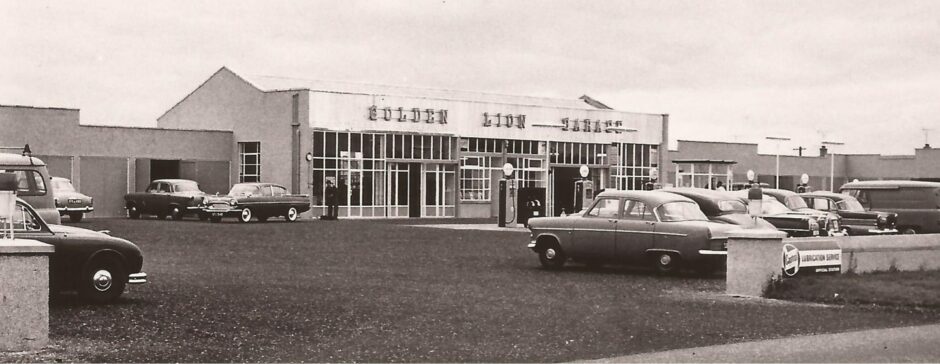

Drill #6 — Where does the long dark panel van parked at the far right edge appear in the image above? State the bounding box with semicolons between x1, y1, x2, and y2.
839;181;940;234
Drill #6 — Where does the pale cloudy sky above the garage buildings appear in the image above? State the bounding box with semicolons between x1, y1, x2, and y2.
0;0;940;155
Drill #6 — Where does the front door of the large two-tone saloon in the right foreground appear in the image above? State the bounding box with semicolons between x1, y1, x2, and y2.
571;197;620;261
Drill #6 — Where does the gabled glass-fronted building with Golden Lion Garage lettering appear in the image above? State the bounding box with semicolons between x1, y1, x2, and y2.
157;67;668;217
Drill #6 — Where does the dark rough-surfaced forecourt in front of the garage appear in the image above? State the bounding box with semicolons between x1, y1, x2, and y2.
0;219;940;362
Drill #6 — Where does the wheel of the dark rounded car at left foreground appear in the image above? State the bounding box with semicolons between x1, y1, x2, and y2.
79;257;127;303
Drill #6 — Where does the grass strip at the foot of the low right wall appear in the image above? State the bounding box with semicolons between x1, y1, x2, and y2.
770;271;940;309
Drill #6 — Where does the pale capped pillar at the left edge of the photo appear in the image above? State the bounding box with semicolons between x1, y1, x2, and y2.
0;239;55;351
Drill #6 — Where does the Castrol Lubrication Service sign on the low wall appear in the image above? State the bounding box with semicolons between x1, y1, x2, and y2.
783;240;842;277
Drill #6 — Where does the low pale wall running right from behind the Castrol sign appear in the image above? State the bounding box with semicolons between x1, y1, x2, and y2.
784;234;940;273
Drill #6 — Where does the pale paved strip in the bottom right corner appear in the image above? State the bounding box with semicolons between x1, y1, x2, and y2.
585;325;940;363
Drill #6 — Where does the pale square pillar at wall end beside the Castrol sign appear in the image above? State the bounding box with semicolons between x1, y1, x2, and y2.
725;229;787;297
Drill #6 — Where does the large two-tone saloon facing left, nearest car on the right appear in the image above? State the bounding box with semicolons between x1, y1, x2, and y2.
528;190;740;273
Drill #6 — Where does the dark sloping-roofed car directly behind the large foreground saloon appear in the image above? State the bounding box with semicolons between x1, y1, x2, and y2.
662;187;777;230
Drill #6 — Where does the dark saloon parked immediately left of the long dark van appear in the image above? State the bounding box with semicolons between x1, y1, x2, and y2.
800;191;898;235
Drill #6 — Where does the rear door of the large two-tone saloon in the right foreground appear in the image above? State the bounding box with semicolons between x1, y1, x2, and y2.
616;199;657;263
